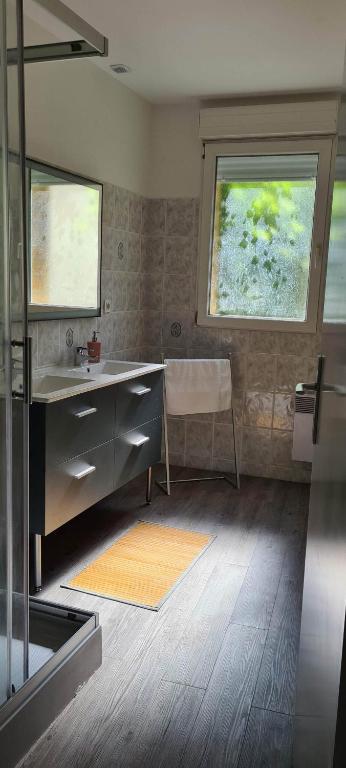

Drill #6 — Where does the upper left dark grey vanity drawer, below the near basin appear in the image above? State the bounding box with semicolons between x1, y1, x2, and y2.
46;387;116;463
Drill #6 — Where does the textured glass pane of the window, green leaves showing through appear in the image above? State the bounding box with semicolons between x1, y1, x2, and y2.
209;155;318;321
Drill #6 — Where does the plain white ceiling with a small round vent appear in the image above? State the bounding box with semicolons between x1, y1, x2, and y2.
25;0;346;103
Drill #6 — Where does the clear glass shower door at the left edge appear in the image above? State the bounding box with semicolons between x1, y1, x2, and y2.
0;0;30;704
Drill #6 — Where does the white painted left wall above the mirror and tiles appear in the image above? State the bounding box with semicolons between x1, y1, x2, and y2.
25;51;152;194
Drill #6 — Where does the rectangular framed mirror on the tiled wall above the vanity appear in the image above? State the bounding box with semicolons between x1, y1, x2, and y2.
27;160;102;320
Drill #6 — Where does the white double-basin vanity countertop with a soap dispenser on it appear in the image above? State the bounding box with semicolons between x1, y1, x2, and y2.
32;360;166;403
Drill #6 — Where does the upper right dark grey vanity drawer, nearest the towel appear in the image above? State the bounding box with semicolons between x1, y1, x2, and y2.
116;371;163;435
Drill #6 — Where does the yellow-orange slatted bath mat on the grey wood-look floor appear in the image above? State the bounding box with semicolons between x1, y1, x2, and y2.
66;522;214;611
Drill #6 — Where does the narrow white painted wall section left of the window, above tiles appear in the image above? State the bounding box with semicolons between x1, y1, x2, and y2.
148;105;202;198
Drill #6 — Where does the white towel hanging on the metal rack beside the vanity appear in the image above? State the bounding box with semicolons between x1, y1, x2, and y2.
164;359;232;416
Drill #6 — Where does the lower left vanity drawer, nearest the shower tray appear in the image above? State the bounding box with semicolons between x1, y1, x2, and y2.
44;441;114;535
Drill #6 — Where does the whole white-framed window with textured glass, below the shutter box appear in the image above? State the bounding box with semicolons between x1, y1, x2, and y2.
198;139;331;331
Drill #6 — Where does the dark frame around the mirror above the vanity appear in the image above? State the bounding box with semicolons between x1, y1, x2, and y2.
26;157;103;321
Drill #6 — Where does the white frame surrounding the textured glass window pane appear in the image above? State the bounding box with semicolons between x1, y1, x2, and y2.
197;136;335;333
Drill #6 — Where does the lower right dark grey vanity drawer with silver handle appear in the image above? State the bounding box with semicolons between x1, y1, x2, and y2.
114;418;161;488
